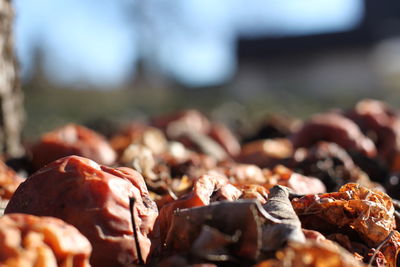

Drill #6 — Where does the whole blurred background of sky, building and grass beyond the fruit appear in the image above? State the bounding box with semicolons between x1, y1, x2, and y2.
14;0;400;139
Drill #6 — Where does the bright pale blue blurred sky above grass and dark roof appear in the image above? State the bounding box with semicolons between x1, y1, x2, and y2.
14;0;363;89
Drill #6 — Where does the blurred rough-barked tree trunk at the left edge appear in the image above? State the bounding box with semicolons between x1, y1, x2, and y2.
0;0;24;157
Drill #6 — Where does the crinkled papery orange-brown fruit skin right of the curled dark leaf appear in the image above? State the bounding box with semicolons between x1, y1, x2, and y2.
292;183;400;267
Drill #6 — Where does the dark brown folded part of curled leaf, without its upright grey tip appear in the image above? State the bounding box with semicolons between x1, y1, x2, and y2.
158;200;280;260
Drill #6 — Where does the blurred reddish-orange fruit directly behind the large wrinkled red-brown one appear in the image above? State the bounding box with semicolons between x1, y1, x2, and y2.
32;123;117;170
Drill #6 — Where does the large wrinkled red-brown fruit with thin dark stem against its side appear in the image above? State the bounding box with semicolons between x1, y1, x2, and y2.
5;156;158;266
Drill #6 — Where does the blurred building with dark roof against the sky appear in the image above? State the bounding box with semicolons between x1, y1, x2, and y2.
233;0;400;98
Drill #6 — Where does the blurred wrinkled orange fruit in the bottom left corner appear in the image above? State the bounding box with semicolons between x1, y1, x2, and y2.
0;213;92;267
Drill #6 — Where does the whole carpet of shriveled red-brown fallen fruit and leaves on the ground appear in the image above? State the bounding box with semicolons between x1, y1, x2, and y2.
0;100;400;267
